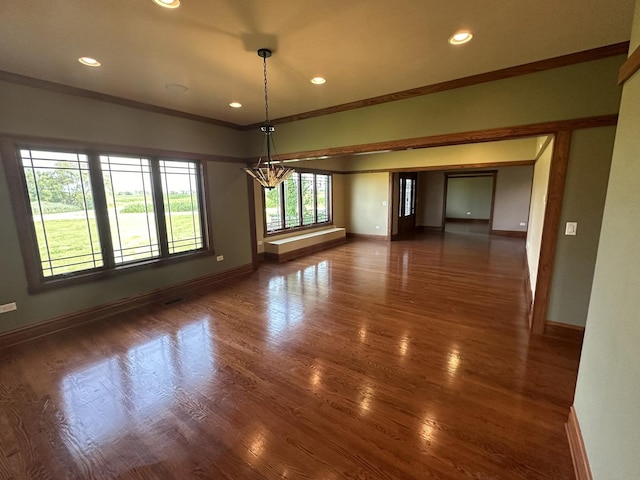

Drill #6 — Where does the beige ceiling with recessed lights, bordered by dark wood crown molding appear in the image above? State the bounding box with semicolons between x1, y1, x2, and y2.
0;0;634;125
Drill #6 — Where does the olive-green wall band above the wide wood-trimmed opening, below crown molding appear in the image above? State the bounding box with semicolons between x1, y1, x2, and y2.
256;56;624;153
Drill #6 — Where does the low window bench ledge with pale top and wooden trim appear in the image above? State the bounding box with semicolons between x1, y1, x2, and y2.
264;227;347;263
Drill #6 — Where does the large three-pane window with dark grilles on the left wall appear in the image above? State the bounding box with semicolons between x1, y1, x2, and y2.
14;142;210;289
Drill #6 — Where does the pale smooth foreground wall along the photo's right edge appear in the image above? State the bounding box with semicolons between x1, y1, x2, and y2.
574;1;640;480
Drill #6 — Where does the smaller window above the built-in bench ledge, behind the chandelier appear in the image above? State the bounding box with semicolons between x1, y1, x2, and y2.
264;172;331;234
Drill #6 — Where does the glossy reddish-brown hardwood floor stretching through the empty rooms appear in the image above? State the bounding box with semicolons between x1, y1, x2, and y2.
0;233;580;480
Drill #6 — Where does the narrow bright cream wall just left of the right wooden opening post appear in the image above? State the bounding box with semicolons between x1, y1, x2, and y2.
527;137;553;295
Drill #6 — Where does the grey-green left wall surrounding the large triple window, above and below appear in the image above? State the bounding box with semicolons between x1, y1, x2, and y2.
0;82;251;332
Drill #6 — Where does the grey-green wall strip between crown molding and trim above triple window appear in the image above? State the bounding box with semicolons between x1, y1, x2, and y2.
0;81;246;157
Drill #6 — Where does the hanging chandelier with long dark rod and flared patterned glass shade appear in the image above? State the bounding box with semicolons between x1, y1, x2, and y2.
244;48;294;188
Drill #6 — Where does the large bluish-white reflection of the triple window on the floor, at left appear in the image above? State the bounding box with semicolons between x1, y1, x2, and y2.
60;319;215;455
